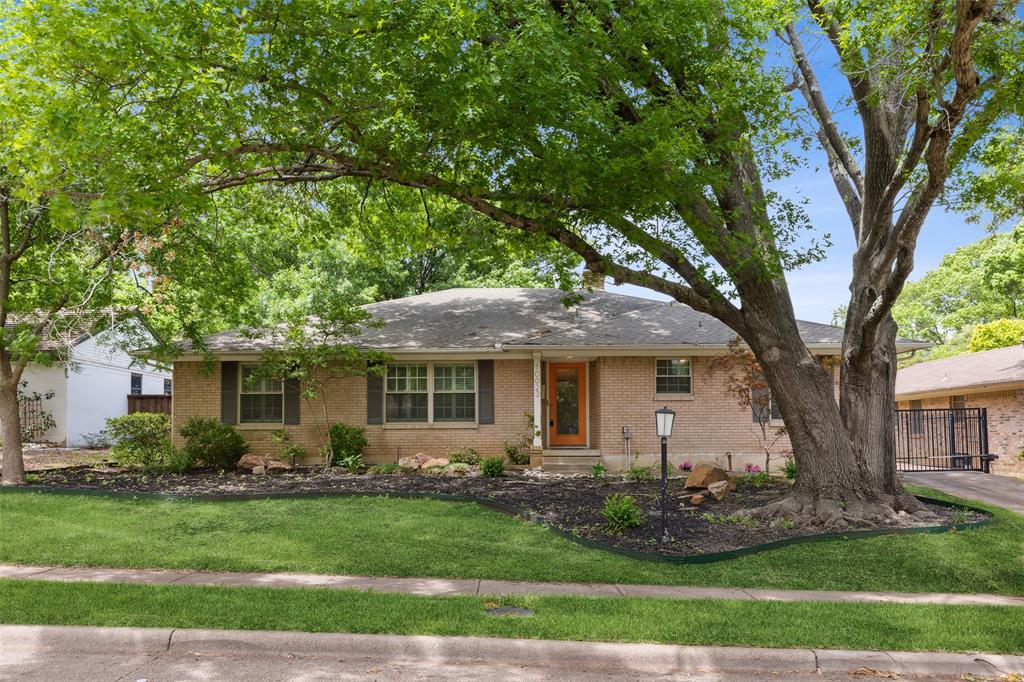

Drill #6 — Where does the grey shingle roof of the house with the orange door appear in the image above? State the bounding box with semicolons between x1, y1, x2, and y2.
176;289;913;353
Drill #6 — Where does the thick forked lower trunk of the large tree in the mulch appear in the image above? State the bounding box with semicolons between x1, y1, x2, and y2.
744;286;928;528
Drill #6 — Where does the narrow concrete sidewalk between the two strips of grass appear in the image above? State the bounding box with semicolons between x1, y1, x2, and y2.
0;564;1024;607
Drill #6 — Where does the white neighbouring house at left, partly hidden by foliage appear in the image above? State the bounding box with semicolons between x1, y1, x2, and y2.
20;321;171;447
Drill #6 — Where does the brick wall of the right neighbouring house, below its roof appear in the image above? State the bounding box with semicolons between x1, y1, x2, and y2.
899;390;1024;475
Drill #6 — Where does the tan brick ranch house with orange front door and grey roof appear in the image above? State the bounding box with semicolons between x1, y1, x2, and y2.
173;282;927;471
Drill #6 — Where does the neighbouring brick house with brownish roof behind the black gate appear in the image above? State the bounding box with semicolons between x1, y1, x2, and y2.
896;345;1024;475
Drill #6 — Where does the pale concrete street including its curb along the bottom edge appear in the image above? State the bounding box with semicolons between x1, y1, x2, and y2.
0;626;1024;682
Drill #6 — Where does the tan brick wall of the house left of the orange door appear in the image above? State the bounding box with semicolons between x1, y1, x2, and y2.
172;359;534;464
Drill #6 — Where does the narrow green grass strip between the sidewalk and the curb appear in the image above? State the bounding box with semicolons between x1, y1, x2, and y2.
0;581;1024;653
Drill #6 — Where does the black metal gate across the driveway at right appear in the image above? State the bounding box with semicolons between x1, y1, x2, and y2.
896;408;992;472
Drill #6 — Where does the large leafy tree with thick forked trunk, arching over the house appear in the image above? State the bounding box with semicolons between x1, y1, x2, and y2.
9;0;1024;526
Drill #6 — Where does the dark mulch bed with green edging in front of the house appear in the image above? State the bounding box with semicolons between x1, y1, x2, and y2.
28;465;984;556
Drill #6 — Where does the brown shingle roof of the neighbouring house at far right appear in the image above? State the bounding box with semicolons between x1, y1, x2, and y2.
896;345;1024;395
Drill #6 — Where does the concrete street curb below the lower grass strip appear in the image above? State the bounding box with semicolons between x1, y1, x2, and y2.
0;626;1024;675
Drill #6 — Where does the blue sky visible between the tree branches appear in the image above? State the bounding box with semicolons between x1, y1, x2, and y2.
608;26;999;323
